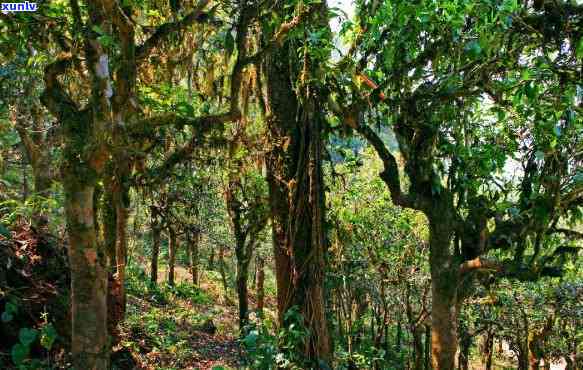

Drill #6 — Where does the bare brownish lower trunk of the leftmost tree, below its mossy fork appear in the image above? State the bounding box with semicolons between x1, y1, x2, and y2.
64;184;109;370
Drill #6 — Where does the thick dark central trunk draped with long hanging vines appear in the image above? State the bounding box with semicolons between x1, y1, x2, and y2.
264;17;332;364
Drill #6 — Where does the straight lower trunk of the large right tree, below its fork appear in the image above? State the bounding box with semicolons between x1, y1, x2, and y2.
429;217;458;370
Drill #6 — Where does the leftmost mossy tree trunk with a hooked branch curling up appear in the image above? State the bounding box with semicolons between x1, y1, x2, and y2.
41;12;111;370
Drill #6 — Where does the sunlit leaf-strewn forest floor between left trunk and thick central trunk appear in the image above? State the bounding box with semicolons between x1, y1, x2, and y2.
113;267;254;370
